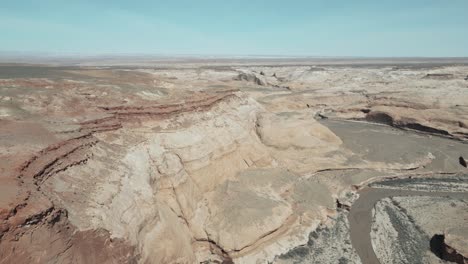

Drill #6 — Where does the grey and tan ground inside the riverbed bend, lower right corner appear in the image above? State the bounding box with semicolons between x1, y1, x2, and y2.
371;196;467;263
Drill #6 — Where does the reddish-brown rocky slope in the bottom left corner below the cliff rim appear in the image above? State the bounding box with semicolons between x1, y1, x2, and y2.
0;208;138;263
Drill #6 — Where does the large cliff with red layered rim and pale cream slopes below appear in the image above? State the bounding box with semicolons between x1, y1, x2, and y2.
1;82;340;263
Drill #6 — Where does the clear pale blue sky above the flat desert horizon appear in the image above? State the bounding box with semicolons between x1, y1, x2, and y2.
0;0;468;57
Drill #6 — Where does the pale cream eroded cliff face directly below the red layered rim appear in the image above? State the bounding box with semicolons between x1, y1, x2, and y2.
46;93;271;263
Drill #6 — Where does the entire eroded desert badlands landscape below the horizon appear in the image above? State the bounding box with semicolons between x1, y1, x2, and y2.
0;59;468;264
